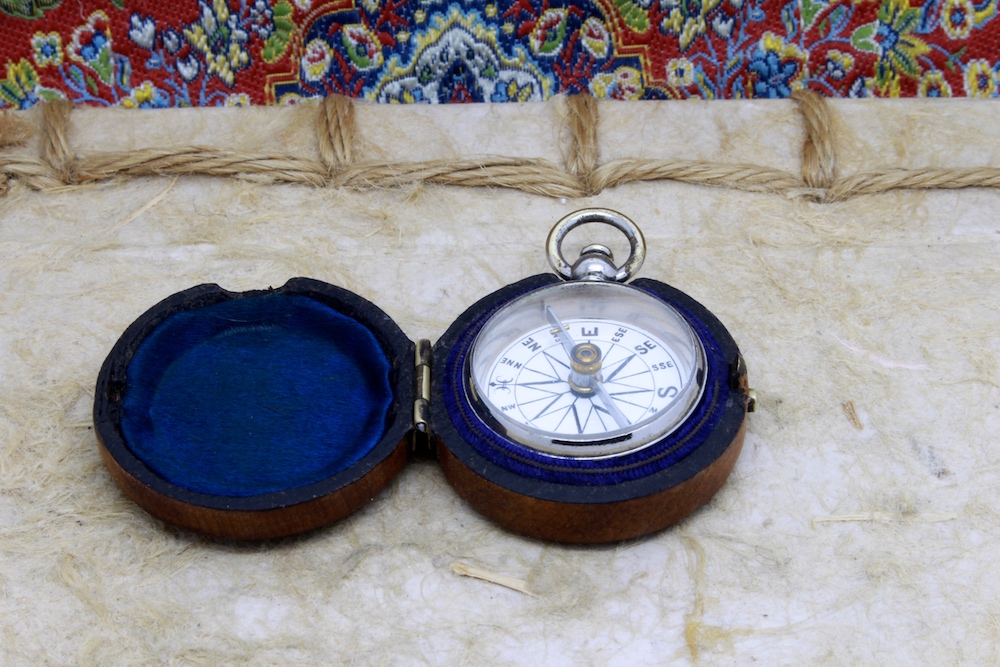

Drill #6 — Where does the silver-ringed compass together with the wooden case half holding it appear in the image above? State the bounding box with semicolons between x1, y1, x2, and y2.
431;209;754;542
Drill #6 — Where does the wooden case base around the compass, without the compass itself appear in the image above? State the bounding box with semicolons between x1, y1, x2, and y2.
432;275;748;542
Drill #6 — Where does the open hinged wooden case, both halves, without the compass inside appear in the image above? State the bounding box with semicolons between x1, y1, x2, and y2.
94;274;748;543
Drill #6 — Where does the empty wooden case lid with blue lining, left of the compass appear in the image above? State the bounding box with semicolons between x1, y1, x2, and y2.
94;278;414;539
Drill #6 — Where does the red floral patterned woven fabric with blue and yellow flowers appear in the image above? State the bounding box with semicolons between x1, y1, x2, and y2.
0;0;1000;109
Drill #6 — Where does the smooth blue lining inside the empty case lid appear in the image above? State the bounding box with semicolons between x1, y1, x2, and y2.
121;294;392;497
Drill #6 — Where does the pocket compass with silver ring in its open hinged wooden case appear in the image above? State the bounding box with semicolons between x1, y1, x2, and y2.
94;209;755;542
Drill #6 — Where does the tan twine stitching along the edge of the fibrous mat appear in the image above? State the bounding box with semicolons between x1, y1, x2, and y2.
0;90;1000;202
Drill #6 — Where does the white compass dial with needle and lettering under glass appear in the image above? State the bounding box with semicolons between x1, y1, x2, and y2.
472;283;704;457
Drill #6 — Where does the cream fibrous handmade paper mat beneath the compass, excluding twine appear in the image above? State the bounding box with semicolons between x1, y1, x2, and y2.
0;101;1000;667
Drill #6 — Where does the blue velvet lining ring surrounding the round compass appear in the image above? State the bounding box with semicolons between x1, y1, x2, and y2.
442;290;730;486
